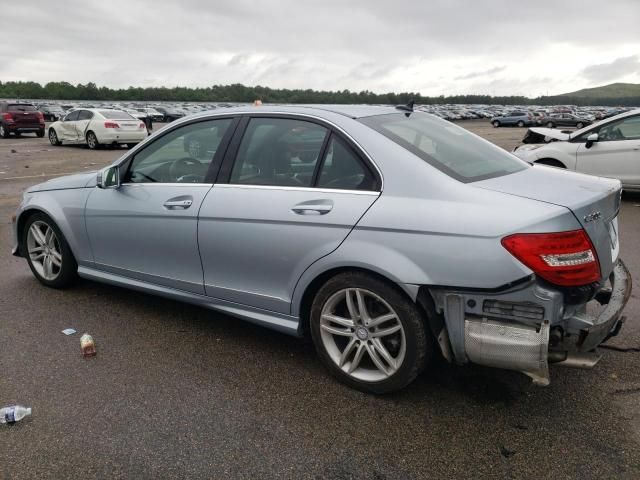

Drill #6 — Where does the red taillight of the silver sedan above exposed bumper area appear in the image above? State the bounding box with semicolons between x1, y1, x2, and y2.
502;230;600;287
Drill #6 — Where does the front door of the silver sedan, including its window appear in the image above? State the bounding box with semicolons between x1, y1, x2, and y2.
85;117;233;294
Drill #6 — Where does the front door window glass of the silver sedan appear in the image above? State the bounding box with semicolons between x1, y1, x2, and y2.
124;118;232;183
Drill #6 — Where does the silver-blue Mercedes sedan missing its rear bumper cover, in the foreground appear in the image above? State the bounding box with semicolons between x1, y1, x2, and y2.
13;105;631;393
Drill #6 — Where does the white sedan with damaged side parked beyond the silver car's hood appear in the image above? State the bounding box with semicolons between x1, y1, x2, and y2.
49;108;147;150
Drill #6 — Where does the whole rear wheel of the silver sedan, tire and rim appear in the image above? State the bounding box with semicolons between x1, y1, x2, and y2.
310;272;432;393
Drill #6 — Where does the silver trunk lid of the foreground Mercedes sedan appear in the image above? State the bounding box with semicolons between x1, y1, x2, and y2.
473;165;622;279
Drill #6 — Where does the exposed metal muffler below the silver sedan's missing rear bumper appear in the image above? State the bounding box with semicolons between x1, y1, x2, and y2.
464;318;550;386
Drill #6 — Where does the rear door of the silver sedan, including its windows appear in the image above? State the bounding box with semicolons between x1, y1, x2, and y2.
198;116;380;314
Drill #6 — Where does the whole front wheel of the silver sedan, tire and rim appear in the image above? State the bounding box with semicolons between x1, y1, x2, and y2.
22;213;78;288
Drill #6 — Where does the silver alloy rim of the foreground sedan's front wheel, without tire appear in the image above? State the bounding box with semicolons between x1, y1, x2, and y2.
27;221;62;281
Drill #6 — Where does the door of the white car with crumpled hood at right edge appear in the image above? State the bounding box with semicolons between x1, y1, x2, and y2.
576;115;640;187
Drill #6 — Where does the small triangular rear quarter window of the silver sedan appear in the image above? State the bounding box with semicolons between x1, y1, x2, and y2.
317;135;376;190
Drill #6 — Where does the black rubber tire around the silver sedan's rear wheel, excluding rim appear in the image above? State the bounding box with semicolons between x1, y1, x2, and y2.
310;272;433;394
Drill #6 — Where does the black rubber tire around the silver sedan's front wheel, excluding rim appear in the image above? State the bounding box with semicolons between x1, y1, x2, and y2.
21;212;78;288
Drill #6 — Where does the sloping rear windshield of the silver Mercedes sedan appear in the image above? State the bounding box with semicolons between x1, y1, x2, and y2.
358;112;527;183
